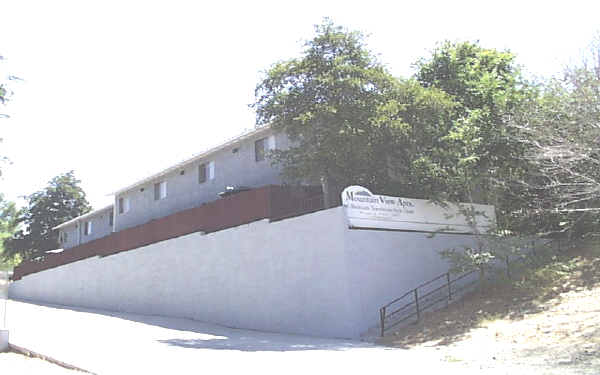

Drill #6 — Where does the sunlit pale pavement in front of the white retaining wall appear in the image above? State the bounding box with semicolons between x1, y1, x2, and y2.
0;300;556;375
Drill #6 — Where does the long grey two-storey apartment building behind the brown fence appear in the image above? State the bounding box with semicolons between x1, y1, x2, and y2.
54;126;289;249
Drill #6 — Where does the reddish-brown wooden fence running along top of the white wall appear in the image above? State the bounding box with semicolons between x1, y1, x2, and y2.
13;185;323;280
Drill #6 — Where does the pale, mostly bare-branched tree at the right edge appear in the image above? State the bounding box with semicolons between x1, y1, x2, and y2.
512;39;600;236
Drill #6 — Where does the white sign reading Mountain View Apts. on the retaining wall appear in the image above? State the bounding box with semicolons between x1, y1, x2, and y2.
342;186;496;233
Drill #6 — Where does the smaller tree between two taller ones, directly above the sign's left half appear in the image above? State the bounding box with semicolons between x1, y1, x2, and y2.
373;79;456;199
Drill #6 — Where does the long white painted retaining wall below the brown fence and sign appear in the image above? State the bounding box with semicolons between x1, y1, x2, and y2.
10;207;478;338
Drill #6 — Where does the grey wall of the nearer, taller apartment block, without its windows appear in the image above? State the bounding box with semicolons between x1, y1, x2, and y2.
115;130;288;231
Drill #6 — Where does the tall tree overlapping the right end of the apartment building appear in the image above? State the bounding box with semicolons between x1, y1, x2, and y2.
253;21;395;209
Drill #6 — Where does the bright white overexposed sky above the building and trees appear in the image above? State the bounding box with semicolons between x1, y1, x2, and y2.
0;0;600;208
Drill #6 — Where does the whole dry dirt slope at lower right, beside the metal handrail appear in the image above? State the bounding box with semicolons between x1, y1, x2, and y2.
379;244;600;374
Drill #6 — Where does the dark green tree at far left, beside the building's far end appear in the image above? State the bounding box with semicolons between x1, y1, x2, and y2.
5;171;91;259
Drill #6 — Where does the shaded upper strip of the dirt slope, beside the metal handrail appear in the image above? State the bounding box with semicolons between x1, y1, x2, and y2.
377;244;600;348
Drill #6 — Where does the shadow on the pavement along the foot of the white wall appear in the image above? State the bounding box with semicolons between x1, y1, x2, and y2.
10;300;374;352
